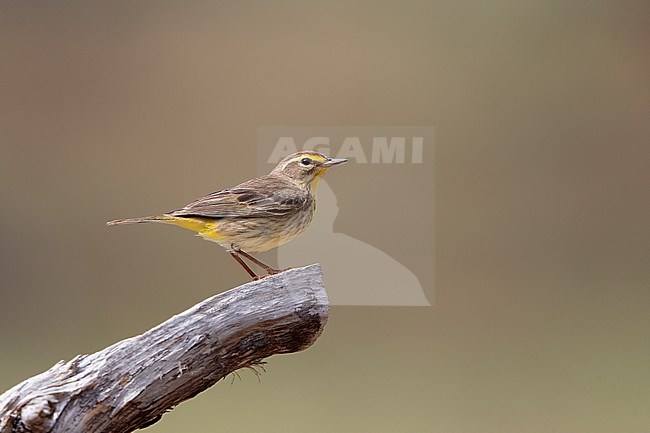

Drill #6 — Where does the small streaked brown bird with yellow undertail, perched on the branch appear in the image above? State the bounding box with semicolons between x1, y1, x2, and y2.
107;151;347;280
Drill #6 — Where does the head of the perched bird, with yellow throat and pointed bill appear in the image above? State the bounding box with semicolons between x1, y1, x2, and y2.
272;151;348;187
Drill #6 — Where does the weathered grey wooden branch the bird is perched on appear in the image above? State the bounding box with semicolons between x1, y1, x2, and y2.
0;265;329;433
